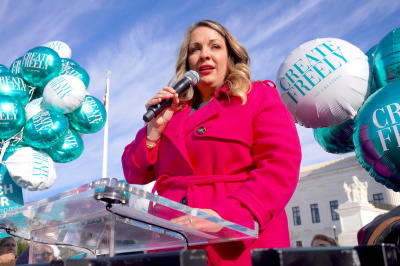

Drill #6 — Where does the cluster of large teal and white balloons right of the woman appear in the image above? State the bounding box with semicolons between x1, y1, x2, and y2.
277;28;400;191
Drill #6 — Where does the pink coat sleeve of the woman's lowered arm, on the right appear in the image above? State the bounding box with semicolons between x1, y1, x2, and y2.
212;82;301;229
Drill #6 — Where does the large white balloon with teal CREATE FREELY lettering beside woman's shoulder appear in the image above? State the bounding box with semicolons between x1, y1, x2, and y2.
276;38;372;128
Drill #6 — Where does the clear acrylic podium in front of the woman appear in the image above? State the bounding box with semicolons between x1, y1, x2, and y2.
0;178;258;262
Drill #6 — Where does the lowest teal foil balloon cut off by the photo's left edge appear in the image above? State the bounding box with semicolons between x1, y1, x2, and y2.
0;95;25;140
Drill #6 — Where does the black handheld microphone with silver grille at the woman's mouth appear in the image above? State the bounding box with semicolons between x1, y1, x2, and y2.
143;70;200;122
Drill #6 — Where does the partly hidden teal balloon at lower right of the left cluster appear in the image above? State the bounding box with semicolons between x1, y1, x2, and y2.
44;130;84;163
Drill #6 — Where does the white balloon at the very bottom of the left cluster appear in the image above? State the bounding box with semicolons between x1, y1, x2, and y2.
5;147;57;191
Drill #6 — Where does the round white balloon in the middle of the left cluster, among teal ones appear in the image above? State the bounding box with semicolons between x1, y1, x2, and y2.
43;75;86;114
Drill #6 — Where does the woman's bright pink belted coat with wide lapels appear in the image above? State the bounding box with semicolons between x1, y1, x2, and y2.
122;81;301;266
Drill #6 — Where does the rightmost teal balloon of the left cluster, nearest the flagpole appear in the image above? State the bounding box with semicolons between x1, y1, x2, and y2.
67;95;107;134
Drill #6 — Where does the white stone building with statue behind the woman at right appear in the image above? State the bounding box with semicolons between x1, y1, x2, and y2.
286;156;400;247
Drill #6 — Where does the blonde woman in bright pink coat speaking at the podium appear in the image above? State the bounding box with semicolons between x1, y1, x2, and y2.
122;20;301;266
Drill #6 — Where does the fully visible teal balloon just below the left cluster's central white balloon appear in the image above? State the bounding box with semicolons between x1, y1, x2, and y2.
23;110;69;149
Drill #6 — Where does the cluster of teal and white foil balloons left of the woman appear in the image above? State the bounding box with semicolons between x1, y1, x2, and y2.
0;41;107;190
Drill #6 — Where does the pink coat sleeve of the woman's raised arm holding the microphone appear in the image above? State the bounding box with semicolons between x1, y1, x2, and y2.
122;127;158;184
